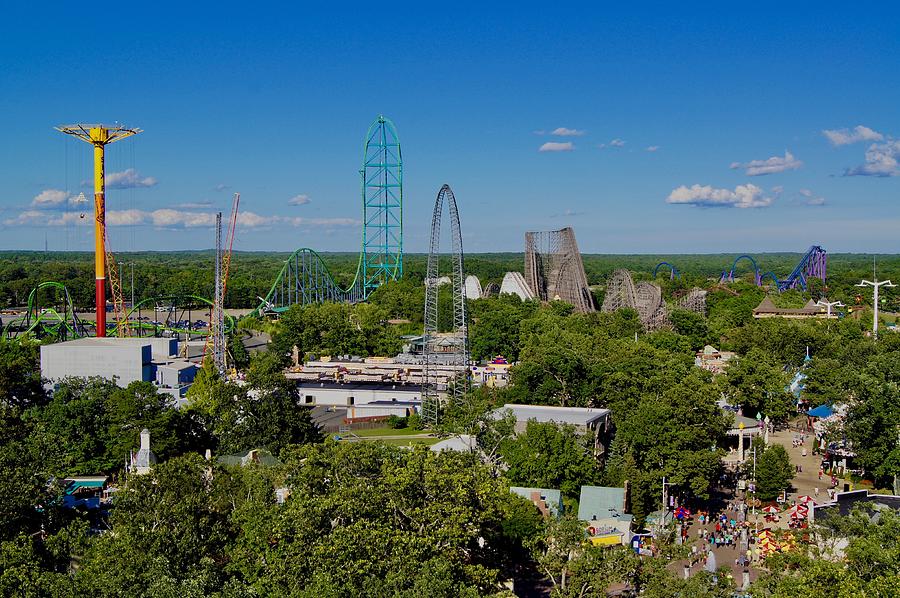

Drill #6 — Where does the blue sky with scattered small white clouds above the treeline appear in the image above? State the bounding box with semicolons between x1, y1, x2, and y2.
0;2;900;253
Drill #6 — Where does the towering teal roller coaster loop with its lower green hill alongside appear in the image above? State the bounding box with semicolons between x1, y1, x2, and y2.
250;116;403;316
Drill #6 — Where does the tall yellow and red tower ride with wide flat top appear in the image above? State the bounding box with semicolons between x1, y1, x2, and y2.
56;125;141;336
